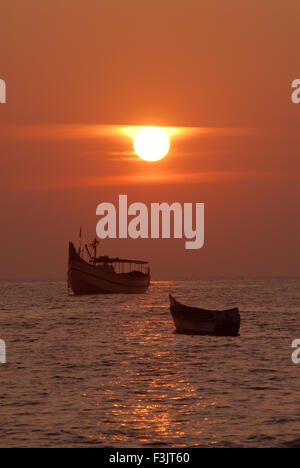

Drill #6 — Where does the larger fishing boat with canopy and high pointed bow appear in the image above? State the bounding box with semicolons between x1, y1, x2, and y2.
68;239;150;295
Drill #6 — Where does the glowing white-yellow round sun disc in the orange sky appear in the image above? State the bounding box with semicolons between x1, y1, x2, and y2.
133;127;170;162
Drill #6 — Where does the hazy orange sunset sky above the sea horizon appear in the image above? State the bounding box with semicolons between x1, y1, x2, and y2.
0;0;300;279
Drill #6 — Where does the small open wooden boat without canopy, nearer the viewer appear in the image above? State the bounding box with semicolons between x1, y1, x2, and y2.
169;295;241;336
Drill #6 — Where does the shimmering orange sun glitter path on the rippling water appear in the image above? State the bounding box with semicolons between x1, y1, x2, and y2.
72;282;232;447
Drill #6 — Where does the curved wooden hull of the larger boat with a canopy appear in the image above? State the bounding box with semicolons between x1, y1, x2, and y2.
68;243;150;295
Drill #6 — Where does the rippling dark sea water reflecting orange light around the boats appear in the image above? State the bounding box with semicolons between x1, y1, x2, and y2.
0;278;300;447
